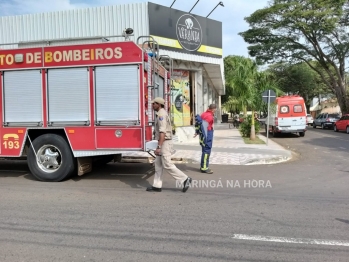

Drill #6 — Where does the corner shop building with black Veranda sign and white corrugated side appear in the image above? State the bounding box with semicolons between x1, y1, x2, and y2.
0;2;225;127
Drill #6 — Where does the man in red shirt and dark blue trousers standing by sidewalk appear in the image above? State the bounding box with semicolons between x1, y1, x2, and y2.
195;104;217;174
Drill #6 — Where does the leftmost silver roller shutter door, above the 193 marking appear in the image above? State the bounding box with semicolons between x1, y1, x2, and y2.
3;70;42;126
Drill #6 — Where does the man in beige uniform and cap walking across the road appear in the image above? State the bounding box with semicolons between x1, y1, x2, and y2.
147;97;192;192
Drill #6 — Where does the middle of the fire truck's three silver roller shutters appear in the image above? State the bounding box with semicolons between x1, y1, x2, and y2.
47;67;90;125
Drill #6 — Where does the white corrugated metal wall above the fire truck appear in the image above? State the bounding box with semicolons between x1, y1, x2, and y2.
0;3;149;46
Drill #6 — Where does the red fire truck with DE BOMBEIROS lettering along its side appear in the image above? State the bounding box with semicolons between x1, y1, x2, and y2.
0;37;171;181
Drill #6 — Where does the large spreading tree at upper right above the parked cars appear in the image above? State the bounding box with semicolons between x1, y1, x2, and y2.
240;0;349;113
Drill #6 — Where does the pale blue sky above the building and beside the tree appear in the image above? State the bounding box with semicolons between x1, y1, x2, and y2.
0;0;268;57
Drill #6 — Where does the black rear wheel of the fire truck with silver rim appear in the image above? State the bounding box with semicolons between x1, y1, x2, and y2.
28;134;75;182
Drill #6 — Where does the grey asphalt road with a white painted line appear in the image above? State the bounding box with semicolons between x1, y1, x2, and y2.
0;128;349;262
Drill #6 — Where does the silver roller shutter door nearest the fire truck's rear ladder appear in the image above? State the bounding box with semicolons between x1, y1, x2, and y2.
95;65;140;125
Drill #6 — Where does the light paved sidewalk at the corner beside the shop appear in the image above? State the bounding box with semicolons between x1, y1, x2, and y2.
119;123;292;165
